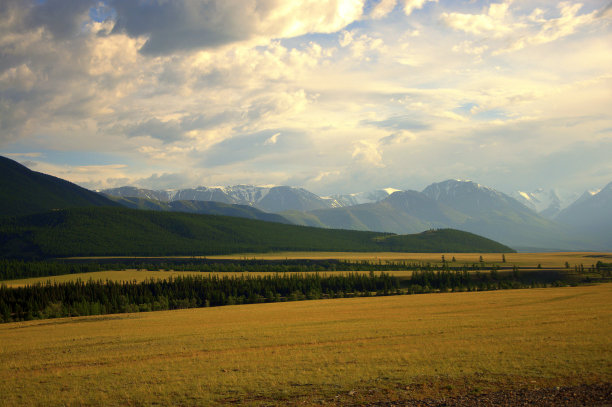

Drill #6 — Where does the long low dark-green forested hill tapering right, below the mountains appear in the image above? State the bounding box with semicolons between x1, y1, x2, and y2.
0;207;513;258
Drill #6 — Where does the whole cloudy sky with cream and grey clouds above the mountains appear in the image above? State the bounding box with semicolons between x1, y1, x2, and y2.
0;0;612;195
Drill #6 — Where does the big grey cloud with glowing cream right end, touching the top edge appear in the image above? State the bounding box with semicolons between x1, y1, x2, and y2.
112;0;364;55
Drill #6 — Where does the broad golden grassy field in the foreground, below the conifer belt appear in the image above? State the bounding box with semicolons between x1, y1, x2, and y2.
0;284;612;405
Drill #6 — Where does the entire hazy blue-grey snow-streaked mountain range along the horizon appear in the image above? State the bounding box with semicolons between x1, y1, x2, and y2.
101;180;612;251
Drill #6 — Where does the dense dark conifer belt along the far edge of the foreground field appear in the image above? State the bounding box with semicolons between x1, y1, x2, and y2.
0;270;584;322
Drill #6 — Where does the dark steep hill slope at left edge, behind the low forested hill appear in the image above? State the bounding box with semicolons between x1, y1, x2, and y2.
0;156;117;216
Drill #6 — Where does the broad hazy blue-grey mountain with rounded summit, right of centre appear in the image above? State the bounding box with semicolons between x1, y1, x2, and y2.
281;179;601;251
